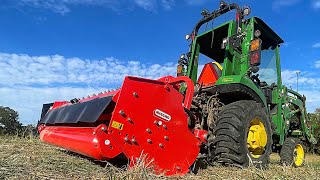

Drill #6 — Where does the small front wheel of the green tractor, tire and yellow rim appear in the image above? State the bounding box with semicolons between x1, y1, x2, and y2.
280;137;305;167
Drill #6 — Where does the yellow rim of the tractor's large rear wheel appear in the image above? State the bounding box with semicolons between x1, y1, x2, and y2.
247;118;268;158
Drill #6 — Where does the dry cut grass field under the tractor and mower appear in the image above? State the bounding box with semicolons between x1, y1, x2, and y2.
0;137;320;179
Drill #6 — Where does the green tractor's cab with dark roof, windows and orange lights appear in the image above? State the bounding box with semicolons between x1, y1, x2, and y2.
178;13;284;91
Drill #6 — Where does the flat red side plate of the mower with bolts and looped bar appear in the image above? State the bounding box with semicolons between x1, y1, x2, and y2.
109;76;199;175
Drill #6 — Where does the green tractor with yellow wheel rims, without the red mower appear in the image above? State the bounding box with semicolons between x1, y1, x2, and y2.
177;1;317;168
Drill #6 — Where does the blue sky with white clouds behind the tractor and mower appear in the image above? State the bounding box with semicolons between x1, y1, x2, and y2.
0;0;320;124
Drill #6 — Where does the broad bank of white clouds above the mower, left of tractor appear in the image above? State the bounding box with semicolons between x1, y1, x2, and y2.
0;53;176;124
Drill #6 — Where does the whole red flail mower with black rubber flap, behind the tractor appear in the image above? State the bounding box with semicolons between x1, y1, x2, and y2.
38;76;208;175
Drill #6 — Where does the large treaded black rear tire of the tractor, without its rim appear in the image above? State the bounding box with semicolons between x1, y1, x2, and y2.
214;100;272;168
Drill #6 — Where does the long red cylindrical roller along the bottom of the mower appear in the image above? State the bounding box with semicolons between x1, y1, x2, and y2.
40;125;122;160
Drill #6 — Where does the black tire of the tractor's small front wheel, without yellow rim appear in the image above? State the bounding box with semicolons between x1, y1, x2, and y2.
280;137;305;167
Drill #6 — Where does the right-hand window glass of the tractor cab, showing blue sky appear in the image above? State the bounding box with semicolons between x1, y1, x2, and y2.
256;48;277;85
